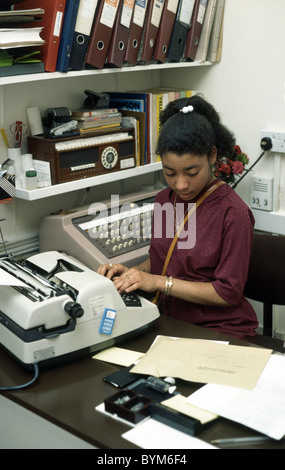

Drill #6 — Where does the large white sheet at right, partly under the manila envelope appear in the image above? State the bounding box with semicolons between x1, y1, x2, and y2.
187;355;285;439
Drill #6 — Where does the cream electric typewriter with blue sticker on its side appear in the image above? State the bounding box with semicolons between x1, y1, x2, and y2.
0;251;159;367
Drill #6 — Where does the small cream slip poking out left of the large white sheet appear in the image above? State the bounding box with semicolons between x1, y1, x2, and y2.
161;394;218;424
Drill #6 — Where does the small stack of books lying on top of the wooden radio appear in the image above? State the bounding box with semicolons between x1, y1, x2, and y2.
71;108;122;134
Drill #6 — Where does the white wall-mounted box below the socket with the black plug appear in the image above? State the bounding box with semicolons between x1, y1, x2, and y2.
250;176;273;212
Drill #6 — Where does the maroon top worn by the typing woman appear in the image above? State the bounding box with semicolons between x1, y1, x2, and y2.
150;180;258;337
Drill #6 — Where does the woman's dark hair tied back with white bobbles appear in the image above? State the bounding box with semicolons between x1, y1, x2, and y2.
156;95;235;159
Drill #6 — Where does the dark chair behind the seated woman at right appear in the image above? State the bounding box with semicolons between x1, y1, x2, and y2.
244;232;285;336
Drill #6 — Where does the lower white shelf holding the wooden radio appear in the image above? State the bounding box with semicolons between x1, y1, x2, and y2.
16;162;162;201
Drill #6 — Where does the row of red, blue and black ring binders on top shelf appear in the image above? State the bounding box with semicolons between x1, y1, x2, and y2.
8;0;225;72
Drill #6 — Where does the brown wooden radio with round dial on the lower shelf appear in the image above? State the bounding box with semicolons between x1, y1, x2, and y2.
28;127;136;184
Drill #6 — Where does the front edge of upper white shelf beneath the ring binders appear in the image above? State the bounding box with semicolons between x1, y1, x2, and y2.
0;61;213;86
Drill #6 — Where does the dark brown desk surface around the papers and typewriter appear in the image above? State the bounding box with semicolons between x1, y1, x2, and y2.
0;316;285;449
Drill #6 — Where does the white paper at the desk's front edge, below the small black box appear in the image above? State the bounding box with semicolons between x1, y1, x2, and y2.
122;418;217;449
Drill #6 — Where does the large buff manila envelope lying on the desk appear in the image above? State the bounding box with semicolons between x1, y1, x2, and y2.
131;336;272;389
